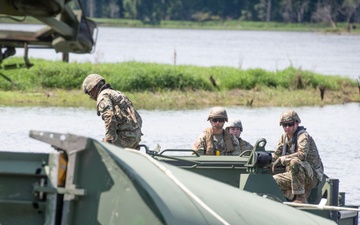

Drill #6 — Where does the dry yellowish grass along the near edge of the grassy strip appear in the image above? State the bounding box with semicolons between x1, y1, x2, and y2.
0;88;360;110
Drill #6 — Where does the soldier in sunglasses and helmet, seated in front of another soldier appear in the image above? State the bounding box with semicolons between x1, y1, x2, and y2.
193;107;240;155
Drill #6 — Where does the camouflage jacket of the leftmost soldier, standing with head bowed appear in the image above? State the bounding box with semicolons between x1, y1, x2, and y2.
96;88;142;147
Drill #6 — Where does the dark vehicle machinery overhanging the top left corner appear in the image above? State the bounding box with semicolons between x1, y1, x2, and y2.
0;0;97;73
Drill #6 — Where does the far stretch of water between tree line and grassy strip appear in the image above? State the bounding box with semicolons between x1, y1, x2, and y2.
0;24;360;79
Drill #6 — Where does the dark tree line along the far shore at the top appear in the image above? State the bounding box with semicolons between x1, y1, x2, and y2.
80;0;360;27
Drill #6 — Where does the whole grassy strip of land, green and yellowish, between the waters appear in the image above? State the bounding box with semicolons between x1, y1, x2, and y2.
0;58;360;110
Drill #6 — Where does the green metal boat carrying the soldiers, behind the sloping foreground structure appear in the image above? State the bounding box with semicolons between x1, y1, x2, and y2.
153;139;359;225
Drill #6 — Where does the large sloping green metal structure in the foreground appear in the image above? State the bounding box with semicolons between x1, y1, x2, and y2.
0;131;342;225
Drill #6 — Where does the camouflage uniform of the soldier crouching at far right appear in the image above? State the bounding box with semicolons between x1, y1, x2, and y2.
274;126;324;199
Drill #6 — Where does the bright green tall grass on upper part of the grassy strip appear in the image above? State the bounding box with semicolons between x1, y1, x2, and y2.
0;57;357;92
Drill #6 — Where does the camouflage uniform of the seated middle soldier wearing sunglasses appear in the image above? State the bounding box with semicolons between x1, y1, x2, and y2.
193;128;240;155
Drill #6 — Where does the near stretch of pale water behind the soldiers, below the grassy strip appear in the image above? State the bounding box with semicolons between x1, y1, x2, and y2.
0;103;360;205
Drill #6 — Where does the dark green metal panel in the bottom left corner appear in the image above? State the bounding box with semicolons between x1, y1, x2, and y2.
0;152;58;225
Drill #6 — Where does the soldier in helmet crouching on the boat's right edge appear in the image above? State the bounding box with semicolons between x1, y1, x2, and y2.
272;109;324;203
